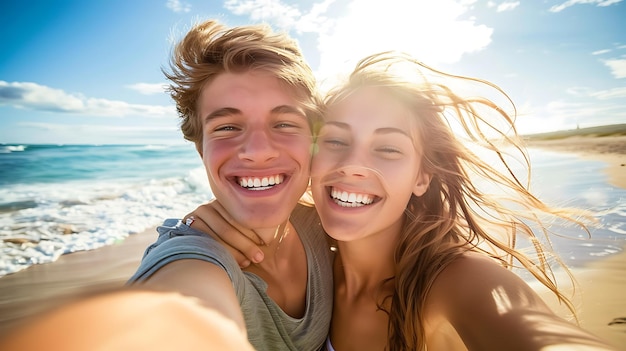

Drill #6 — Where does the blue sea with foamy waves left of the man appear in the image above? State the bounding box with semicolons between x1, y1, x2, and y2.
0;143;213;276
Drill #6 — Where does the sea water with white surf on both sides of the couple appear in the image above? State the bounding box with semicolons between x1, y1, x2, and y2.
0;144;626;276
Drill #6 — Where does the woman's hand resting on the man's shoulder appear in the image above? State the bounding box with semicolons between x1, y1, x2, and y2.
183;200;264;268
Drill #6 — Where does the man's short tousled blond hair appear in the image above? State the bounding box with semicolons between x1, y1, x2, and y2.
163;20;322;150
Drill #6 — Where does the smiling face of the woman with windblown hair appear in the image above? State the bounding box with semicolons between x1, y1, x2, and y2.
311;87;428;241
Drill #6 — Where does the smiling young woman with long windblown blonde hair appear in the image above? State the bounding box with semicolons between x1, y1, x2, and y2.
186;53;612;351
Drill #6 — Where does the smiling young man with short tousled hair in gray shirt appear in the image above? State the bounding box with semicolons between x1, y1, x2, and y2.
125;21;333;350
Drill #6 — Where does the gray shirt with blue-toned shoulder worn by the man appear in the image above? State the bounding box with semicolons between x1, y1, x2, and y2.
129;205;333;351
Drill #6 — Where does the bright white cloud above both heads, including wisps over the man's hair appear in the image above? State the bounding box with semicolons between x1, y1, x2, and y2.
224;0;490;84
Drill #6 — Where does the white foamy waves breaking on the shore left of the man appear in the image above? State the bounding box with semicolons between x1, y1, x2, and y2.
0;169;213;277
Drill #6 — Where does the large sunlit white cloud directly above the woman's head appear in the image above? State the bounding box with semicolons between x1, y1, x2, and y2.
318;0;493;84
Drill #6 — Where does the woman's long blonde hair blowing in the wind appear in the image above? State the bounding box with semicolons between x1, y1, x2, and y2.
326;52;588;350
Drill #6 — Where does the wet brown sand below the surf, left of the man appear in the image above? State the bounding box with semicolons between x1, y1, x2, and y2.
0;228;157;334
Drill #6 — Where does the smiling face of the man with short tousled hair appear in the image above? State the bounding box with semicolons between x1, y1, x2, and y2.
198;71;312;229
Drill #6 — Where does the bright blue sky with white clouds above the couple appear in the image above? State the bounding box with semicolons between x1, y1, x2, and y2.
0;0;626;144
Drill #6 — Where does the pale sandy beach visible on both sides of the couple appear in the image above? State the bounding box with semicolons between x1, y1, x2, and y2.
0;135;626;350
